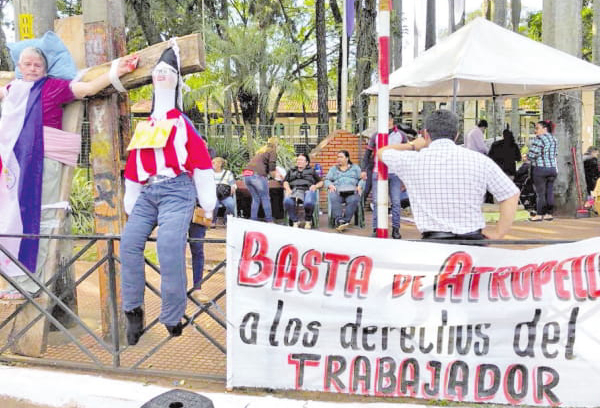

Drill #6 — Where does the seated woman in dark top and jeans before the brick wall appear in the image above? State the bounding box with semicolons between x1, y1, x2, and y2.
283;153;323;229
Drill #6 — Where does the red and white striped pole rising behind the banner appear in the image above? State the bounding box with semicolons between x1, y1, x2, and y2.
375;0;391;238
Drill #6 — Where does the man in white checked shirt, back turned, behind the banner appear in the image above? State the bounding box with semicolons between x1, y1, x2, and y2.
377;110;519;239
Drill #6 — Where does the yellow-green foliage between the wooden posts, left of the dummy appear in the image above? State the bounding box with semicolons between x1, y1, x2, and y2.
69;168;94;235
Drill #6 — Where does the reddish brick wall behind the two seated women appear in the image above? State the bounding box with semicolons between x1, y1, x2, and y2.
310;130;368;207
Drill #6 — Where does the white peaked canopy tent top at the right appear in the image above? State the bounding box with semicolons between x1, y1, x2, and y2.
364;17;600;100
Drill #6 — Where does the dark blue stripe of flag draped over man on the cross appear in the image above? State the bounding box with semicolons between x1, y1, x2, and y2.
13;78;46;272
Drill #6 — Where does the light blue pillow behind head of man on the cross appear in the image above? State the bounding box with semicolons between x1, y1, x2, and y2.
7;31;77;80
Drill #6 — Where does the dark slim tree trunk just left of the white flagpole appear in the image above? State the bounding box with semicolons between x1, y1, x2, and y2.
315;0;329;142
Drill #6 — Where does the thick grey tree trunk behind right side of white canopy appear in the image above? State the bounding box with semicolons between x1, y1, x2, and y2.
542;0;585;216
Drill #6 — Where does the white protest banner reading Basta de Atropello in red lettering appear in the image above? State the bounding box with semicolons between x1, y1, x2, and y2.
227;218;600;407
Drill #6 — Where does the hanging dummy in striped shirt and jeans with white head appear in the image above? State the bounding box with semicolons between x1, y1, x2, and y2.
121;40;216;345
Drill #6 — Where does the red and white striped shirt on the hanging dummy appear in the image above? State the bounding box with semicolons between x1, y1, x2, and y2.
125;109;212;184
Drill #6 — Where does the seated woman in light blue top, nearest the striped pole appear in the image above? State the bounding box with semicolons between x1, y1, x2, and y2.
325;150;363;232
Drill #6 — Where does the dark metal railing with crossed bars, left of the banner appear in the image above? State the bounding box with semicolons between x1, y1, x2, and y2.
0;235;226;381
